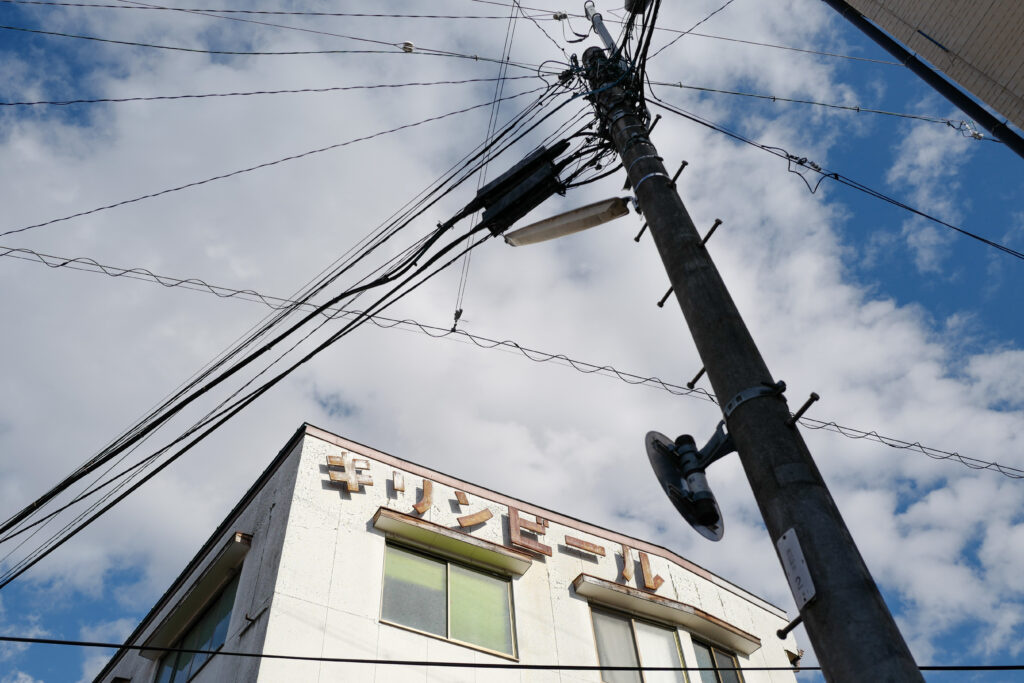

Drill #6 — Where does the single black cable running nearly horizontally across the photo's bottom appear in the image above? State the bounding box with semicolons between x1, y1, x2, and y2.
0;636;1024;673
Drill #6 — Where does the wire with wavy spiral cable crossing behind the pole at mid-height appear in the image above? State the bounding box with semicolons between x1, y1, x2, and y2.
0;247;1024;479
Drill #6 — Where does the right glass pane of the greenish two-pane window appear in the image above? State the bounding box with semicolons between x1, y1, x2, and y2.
449;564;512;654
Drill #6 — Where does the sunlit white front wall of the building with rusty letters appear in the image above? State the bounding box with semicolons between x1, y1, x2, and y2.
258;435;797;683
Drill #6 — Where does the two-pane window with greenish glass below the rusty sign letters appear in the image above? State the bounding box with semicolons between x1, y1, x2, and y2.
381;546;515;656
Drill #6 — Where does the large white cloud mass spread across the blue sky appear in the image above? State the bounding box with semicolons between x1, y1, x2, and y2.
0;2;1024;674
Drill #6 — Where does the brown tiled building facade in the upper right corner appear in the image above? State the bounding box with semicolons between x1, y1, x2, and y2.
846;0;1024;128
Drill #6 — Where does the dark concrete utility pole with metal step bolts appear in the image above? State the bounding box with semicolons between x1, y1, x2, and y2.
583;47;924;683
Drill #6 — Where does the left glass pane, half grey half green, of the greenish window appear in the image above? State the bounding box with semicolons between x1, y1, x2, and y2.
381;546;447;636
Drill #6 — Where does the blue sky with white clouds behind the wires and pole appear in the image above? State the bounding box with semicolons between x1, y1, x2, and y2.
0;0;1024;683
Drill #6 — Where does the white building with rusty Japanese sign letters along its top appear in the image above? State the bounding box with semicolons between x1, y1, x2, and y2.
96;425;798;683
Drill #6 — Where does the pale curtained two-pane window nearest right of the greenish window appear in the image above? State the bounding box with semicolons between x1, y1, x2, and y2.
591;609;688;683
